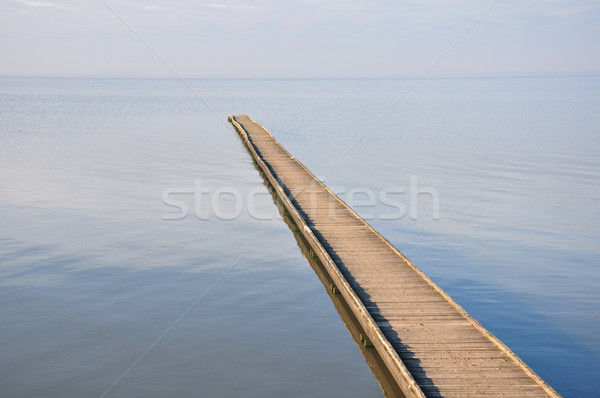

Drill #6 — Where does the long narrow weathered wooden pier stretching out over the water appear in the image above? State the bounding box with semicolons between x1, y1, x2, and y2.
229;115;560;397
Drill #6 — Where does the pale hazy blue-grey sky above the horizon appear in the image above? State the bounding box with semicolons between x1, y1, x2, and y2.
0;0;600;78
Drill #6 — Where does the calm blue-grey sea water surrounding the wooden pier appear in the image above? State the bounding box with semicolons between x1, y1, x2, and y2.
0;77;600;397
